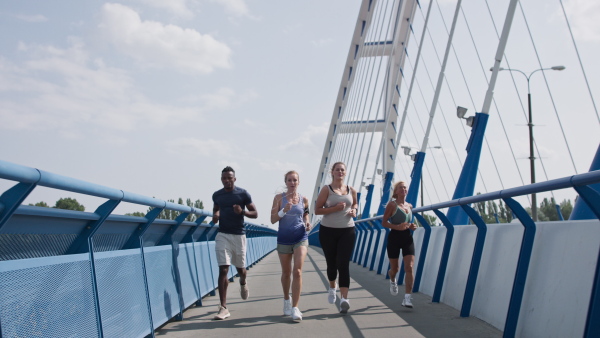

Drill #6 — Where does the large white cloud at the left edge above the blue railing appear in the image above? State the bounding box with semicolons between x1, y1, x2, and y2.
0;38;202;132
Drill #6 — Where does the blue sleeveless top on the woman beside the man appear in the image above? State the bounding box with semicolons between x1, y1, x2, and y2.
277;193;308;245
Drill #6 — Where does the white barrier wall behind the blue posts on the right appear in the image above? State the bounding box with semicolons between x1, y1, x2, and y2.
374;220;600;337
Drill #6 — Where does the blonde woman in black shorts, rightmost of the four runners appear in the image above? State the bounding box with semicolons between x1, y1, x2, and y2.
382;181;417;308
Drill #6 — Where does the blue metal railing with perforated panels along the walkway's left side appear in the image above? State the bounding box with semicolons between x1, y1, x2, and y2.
0;161;276;337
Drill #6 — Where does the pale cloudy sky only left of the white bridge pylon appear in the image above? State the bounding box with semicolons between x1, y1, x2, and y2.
0;0;360;224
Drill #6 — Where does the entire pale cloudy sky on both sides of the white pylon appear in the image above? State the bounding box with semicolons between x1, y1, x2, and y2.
0;0;600;227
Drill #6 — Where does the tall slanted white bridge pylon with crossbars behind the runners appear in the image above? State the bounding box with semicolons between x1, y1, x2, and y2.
311;0;417;219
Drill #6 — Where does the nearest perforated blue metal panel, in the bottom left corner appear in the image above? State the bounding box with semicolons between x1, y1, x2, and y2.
0;254;98;338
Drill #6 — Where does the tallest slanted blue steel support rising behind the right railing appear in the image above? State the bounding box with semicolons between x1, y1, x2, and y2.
448;113;489;225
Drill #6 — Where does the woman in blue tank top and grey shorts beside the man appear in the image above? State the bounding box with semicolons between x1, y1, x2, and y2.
271;170;310;322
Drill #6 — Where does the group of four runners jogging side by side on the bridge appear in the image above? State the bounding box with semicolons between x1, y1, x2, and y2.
212;162;417;322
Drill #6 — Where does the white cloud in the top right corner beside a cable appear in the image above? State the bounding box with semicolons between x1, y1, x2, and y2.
559;0;600;42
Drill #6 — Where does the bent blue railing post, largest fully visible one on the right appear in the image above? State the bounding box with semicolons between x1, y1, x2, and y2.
502;198;535;337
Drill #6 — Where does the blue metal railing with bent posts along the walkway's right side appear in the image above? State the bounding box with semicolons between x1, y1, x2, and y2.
309;170;600;337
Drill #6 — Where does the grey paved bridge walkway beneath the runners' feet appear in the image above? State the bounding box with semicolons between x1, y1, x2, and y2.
156;246;502;338
